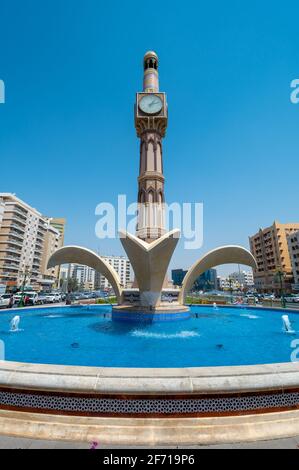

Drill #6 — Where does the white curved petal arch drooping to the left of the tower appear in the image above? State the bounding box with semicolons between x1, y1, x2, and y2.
47;246;122;303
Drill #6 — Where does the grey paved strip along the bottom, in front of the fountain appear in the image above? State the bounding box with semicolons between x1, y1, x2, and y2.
0;436;299;449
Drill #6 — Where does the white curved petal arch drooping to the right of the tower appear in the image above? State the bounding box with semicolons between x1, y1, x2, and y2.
180;245;257;304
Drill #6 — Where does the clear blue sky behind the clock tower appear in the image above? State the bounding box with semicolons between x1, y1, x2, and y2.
0;0;299;272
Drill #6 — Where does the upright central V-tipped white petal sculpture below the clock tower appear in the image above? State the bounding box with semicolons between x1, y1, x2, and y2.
119;229;180;308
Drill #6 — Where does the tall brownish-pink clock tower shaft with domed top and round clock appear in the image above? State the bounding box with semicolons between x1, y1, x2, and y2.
135;51;167;243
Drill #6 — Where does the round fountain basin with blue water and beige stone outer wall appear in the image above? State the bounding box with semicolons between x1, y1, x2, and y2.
0;306;299;445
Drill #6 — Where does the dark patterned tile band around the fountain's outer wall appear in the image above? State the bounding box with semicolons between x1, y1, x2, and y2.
0;389;299;417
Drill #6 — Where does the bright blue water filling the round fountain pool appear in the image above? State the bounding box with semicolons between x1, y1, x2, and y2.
0;306;299;367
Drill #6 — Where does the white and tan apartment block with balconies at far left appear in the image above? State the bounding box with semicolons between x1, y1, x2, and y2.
0;193;63;290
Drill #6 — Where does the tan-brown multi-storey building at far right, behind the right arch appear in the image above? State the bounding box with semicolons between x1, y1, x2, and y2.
249;221;299;294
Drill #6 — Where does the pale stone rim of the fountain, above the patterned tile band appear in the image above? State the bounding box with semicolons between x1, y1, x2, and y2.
0;361;299;395
